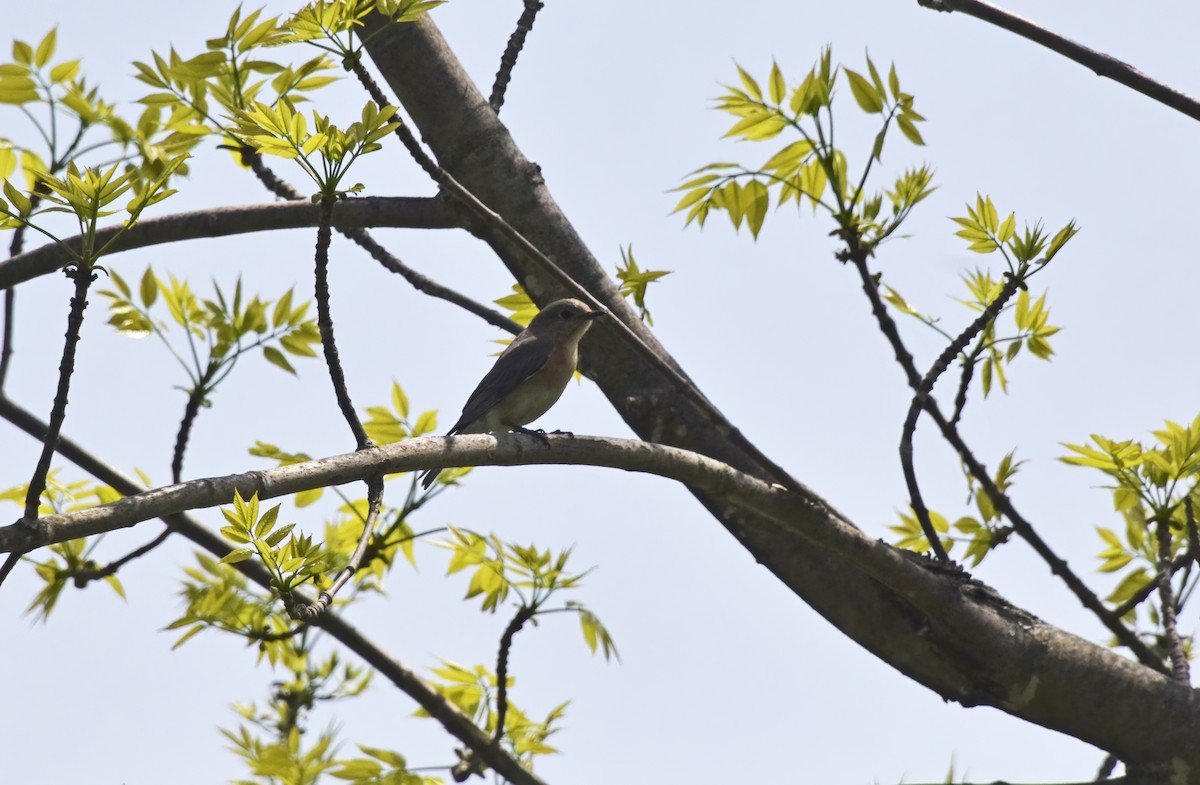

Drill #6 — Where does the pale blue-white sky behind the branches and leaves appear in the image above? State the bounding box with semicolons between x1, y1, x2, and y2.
0;0;1200;785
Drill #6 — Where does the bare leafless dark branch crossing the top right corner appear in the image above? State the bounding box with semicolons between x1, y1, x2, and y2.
917;0;1200;120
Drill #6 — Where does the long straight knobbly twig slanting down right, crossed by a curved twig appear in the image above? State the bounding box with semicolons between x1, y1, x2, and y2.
847;248;1168;673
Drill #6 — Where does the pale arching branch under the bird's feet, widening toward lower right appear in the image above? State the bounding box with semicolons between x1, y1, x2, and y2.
0;424;1200;771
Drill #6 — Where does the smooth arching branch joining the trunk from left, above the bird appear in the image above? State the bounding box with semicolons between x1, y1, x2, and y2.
0;197;460;288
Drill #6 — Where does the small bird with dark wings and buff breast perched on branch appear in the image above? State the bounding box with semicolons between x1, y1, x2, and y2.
421;299;605;489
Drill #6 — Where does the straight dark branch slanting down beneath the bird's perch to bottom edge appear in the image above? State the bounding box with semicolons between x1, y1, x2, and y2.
0;394;542;785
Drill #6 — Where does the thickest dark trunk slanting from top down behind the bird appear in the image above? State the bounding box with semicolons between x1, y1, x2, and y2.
350;16;1200;772
